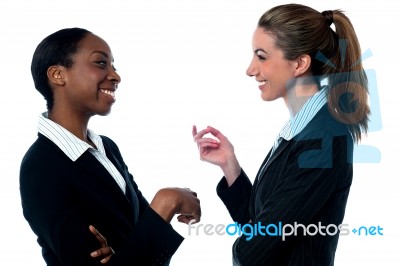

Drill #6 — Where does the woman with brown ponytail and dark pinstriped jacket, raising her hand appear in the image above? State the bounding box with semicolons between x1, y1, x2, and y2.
192;4;370;266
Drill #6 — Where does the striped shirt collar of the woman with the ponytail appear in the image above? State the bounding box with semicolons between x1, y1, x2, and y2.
271;86;327;155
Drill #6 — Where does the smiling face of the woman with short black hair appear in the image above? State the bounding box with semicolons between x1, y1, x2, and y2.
53;34;121;117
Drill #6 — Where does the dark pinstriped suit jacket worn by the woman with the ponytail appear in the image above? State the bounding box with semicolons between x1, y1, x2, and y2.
217;105;353;266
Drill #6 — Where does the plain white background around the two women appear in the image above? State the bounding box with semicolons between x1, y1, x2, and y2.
0;0;400;266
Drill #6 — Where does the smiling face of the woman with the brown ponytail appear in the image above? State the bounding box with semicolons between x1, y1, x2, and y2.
246;28;296;101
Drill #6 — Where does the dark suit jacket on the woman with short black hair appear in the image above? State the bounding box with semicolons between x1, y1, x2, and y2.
20;134;183;266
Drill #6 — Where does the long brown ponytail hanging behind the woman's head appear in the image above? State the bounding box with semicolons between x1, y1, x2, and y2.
327;10;370;141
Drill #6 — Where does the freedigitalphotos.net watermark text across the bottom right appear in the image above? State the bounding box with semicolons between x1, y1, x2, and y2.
188;221;383;241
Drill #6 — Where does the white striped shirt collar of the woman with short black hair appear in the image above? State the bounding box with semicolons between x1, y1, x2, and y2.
38;112;126;194
